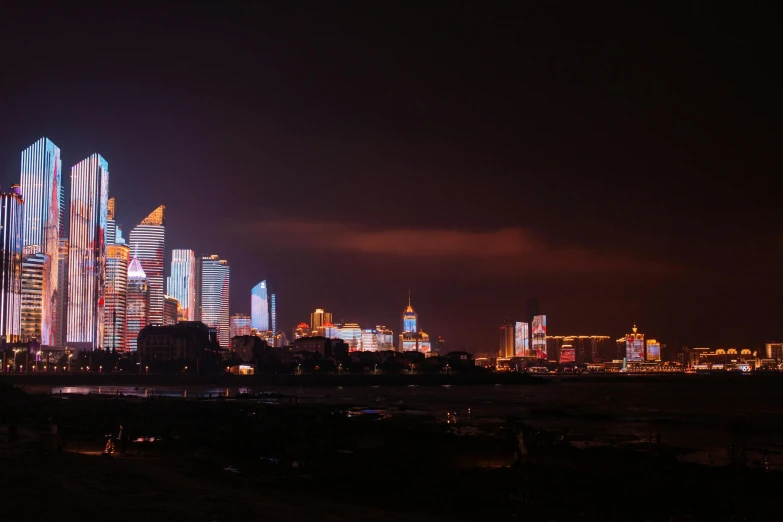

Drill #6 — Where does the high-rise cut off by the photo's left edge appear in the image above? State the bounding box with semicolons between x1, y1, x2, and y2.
0;185;24;343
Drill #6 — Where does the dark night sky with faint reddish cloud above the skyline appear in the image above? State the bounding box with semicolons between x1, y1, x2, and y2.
0;1;783;351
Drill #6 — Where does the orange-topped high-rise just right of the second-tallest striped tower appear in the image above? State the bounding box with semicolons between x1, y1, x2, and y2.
103;244;130;351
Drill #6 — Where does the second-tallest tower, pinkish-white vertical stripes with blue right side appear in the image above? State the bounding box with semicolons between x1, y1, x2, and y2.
67;154;109;350
